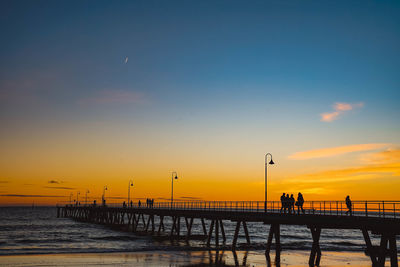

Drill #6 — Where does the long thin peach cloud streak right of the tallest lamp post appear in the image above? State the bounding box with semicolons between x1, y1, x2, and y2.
289;144;390;160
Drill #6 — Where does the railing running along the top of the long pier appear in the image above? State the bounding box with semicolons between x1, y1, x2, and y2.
67;201;400;219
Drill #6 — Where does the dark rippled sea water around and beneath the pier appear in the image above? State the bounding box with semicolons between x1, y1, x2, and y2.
0;207;400;255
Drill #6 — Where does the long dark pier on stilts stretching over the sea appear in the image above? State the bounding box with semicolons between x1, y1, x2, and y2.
57;201;400;267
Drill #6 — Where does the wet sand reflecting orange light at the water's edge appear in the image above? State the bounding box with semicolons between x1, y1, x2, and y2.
0;251;371;267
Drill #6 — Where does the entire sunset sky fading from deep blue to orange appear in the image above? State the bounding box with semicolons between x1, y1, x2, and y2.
0;0;400;205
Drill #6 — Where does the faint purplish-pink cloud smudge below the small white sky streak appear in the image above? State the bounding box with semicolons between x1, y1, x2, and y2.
78;90;144;105
